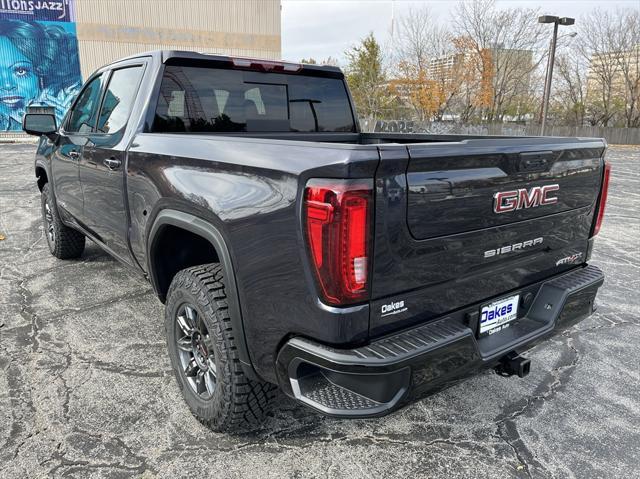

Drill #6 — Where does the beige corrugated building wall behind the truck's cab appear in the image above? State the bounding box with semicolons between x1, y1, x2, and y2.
75;0;281;78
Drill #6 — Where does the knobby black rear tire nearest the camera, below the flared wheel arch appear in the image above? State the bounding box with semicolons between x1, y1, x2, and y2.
165;263;277;432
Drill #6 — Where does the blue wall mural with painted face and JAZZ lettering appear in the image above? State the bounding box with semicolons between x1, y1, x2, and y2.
0;0;82;131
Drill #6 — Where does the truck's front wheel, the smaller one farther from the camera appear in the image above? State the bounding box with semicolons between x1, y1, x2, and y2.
41;183;85;259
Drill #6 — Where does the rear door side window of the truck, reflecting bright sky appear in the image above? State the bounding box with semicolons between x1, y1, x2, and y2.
98;65;142;133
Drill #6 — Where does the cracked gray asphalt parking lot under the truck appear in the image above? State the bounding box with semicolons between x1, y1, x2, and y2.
0;145;640;479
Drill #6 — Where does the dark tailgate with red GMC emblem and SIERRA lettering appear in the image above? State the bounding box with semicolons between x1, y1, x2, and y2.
370;138;605;335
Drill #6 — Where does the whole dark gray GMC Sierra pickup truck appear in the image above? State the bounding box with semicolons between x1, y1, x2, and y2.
23;51;609;430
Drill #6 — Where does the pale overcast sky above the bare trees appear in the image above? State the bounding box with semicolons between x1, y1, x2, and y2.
282;0;640;62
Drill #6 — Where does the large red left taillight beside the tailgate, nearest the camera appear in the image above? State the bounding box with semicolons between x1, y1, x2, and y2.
304;179;373;305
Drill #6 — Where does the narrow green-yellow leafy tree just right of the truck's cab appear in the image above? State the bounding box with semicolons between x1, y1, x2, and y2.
345;33;392;119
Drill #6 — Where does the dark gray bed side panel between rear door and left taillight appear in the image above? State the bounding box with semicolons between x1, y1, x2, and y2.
127;134;379;381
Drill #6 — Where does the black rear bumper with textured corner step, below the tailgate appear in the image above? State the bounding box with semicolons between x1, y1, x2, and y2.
277;266;604;417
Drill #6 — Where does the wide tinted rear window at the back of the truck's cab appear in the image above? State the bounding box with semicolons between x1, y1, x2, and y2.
153;65;355;133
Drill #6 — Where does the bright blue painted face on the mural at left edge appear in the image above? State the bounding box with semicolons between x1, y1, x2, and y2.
0;37;40;112
